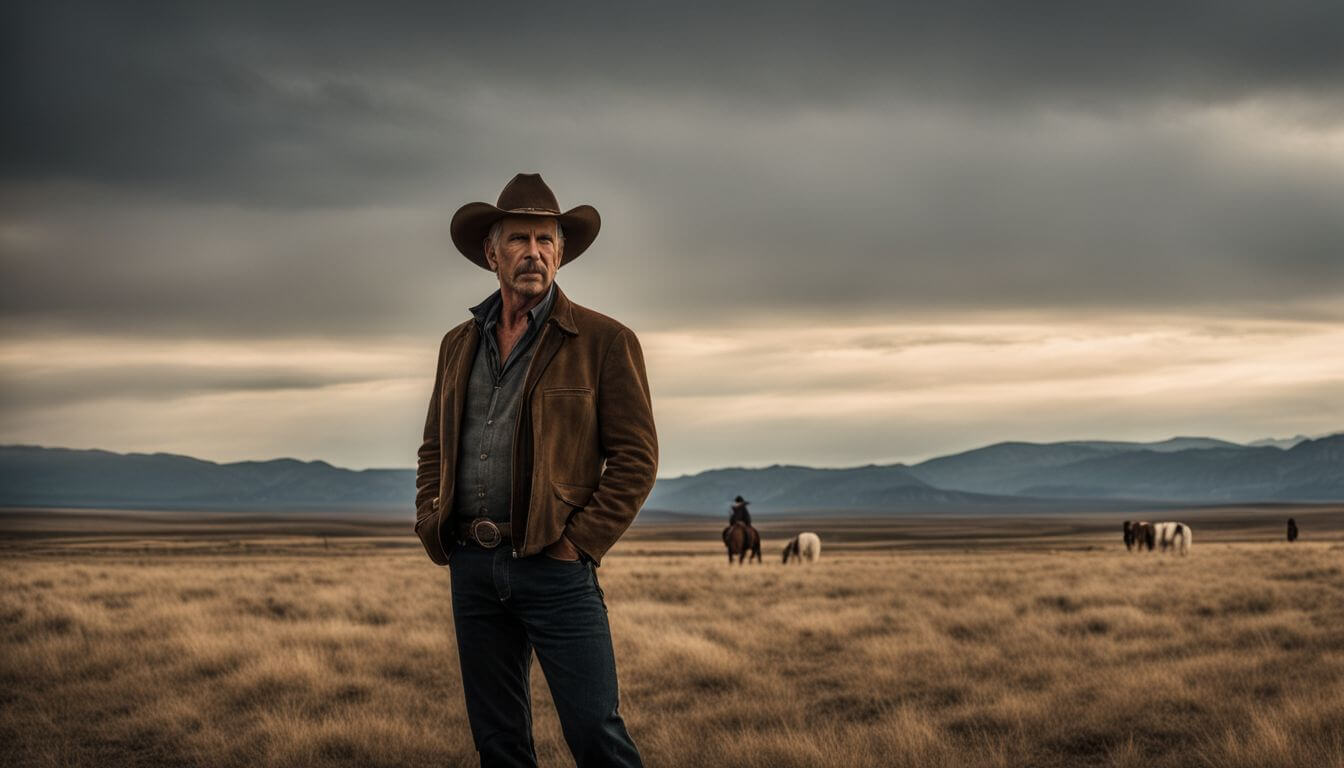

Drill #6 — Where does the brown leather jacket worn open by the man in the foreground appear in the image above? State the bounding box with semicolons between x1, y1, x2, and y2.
415;285;659;565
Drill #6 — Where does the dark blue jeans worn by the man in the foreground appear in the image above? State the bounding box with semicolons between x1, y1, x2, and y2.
449;543;642;768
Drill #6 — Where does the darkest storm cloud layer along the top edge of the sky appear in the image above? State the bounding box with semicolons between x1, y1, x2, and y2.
0;0;1344;206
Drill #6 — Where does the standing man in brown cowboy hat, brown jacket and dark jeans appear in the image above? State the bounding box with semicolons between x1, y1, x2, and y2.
415;174;657;767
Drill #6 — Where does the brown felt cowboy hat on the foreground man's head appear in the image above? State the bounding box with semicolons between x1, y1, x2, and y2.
449;174;602;269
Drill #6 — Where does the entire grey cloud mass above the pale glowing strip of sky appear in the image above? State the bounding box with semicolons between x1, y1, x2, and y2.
0;1;1344;338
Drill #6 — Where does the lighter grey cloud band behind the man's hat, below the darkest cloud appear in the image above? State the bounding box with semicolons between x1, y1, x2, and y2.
0;104;1344;336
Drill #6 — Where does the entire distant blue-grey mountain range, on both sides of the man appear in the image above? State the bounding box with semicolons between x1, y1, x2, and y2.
0;433;1344;514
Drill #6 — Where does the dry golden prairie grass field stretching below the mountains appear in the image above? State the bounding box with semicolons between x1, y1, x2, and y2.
0;510;1344;768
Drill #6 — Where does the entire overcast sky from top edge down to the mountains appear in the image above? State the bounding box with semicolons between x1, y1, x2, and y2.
0;1;1344;476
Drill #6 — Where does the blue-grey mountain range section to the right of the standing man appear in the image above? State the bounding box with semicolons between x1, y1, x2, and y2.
645;433;1344;511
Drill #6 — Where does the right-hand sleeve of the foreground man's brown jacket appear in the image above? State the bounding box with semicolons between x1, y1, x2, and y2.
564;328;659;564
